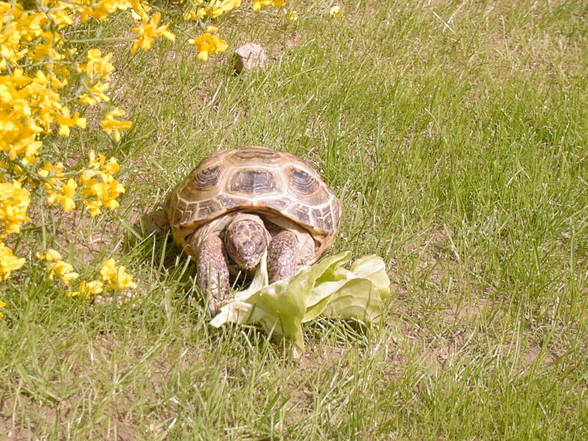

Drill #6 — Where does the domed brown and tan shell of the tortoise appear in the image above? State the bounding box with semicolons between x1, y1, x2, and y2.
166;146;341;259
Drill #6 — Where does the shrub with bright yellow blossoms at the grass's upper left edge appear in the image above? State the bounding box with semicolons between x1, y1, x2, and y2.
0;0;292;316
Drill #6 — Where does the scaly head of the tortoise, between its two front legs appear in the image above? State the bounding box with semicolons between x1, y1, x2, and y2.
225;216;268;271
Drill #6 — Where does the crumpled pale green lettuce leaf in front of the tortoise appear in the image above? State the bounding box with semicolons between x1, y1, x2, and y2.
211;251;390;354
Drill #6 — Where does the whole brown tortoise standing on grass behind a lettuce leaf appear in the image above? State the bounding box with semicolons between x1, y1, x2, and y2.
165;146;342;312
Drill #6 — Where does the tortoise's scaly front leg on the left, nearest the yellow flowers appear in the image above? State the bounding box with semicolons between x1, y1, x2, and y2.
190;235;229;314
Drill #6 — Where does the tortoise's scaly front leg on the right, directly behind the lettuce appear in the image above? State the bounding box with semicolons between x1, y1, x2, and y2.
268;231;300;283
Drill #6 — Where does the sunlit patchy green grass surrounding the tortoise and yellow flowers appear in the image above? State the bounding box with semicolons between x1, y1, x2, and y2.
0;0;588;441
